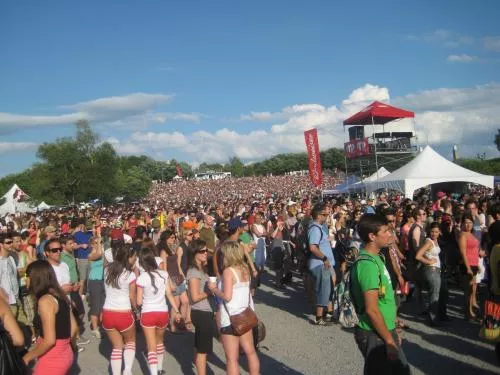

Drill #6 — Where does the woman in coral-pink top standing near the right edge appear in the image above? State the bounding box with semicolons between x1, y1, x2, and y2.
458;215;484;319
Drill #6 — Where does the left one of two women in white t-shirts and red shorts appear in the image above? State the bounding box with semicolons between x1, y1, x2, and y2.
102;244;137;375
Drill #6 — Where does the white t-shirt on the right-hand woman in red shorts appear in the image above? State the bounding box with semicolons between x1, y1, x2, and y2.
137;270;168;312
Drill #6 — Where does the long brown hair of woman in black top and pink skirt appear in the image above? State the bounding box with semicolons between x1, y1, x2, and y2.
26;260;66;301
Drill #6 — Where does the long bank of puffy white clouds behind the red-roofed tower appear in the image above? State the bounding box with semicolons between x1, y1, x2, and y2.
111;83;500;162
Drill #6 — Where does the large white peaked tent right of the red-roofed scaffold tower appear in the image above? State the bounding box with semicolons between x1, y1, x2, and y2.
366;146;494;198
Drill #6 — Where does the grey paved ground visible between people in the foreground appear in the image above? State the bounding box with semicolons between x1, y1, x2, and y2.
73;274;500;375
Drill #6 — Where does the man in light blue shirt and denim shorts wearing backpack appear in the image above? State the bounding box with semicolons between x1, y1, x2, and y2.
307;203;335;326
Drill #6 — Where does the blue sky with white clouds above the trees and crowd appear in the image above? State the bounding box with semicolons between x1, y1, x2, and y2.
0;0;500;176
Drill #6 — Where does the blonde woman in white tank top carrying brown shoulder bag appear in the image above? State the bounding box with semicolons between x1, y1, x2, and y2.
208;241;260;375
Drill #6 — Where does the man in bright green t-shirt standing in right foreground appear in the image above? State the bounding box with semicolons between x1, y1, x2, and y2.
351;215;410;374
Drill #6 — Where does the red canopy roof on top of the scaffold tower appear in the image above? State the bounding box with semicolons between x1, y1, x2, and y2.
344;101;415;126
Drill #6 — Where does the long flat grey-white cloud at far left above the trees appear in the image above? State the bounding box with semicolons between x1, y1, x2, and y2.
0;93;204;133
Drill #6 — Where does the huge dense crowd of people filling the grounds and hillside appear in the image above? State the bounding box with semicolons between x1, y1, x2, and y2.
0;176;500;375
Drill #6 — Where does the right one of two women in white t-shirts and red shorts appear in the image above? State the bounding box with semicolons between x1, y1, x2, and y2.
137;247;180;375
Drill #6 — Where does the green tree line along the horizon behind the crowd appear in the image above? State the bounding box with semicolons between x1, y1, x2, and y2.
0;120;500;205
